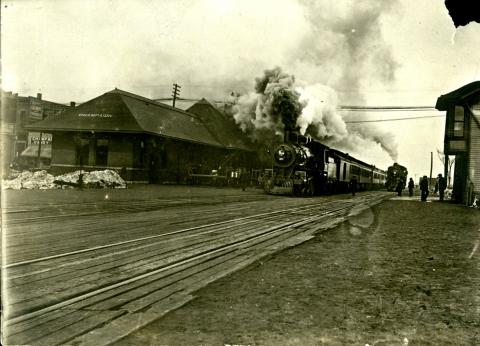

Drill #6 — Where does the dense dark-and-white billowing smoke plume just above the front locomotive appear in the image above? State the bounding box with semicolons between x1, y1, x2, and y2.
234;67;397;161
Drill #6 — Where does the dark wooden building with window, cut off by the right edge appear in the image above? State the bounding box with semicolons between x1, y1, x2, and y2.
435;81;480;205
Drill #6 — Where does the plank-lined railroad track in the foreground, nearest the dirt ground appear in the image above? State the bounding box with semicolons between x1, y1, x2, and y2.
4;193;390;345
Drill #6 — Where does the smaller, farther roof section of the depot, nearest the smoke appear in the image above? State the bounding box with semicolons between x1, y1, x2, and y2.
187;98;253;151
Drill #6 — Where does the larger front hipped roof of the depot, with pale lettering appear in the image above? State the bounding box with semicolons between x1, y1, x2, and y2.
27;89;223;147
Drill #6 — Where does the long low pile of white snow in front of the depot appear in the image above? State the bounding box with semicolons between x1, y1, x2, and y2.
2;169;126;190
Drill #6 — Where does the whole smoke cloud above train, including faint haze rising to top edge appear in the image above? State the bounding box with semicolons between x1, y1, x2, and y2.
229;0;398;161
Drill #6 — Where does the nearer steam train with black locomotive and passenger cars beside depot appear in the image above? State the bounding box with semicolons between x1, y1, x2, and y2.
264;132;386;196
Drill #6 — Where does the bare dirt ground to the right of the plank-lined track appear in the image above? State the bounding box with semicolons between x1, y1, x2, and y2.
117;197;480;346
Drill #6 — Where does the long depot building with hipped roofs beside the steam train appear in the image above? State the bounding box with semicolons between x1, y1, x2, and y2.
28;89;256;183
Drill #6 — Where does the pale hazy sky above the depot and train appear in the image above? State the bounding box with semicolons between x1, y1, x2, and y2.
1;0;480;179
